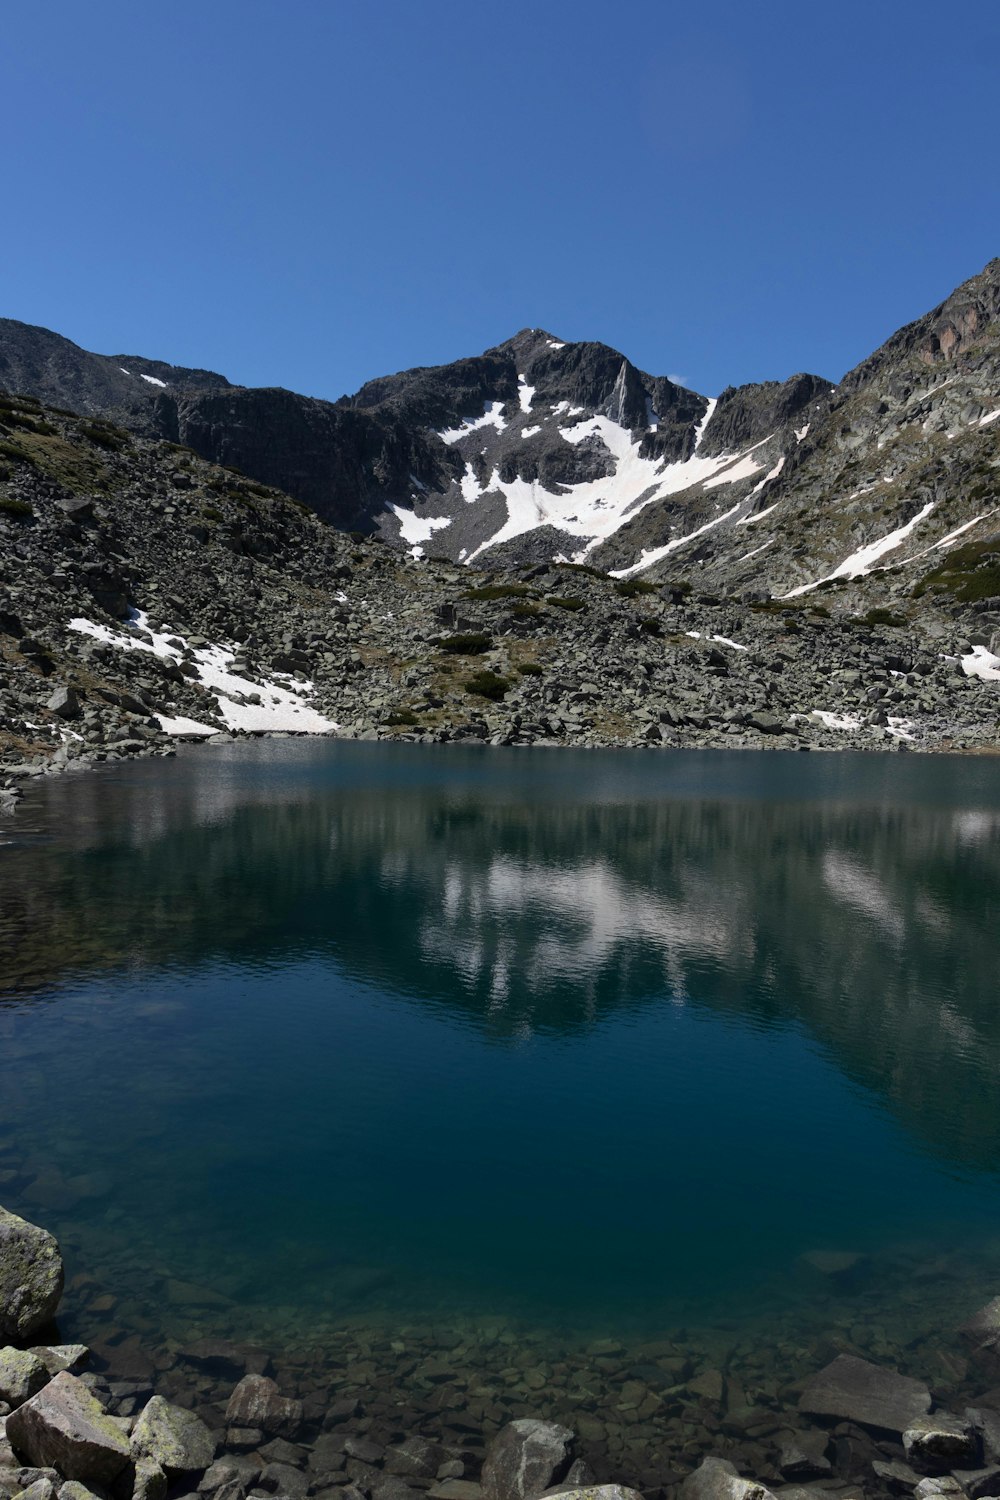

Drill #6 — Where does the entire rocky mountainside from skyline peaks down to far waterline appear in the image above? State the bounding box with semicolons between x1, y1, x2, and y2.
0;261;1000;807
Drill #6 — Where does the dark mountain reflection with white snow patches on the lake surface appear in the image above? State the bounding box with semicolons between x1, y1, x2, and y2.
0;747;1000;1167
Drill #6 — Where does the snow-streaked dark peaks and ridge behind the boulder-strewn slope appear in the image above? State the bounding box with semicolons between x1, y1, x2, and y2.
0;260;1000;597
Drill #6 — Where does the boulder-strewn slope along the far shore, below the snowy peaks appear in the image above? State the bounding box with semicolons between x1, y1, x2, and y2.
0;398;1000;804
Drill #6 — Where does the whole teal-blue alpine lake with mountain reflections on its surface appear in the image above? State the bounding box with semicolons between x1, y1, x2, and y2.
0;741;1000;1428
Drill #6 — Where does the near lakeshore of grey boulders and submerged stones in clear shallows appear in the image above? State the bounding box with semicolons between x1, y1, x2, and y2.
7;1211;1000;1500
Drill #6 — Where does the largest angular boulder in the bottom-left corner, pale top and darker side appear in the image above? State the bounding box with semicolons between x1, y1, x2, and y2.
7;1371;130;1485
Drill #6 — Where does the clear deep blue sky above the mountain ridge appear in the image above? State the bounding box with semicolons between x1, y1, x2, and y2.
0;0;1000;398
